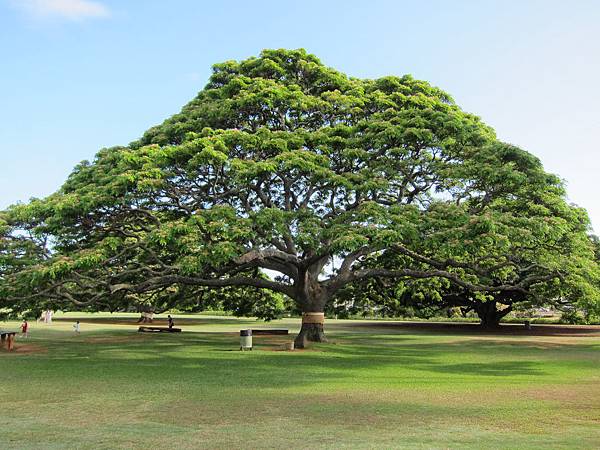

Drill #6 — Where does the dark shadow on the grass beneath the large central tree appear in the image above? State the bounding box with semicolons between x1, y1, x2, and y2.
8;330;544;389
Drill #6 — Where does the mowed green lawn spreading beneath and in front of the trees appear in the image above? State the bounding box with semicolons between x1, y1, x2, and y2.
0;315;600;450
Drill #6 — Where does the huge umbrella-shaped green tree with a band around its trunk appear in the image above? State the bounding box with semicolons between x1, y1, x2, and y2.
0;50;596;347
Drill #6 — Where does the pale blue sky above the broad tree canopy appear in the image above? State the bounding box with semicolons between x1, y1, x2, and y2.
0;0;600;232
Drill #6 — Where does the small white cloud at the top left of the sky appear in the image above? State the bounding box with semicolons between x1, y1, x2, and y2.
13;0;110;20
